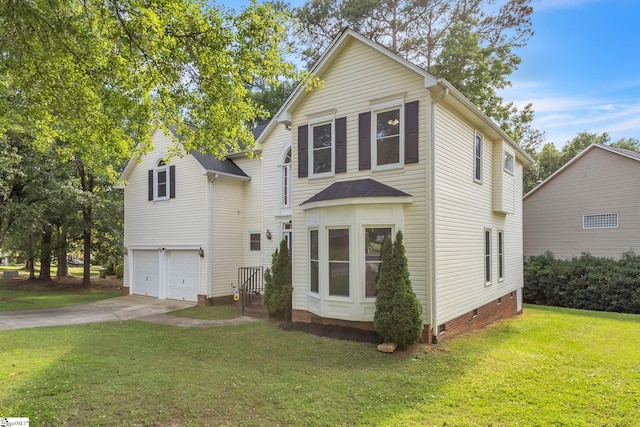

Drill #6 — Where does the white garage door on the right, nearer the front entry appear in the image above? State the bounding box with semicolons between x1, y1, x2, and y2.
166;250;200;301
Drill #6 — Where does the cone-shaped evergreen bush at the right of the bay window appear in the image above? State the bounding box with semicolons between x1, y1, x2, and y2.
373;231;424;347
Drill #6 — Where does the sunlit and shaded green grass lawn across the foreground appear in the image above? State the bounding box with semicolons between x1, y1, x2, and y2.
0;306;640;426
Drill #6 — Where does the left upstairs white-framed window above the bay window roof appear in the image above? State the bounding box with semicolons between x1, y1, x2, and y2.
309;115;335;177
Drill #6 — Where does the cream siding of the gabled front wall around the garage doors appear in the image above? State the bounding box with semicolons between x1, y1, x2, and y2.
124;128;207;293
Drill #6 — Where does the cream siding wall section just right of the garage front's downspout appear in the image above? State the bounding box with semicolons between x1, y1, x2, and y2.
212;176;249;297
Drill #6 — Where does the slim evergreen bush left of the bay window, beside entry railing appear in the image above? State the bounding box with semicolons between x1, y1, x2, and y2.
264;240;293;320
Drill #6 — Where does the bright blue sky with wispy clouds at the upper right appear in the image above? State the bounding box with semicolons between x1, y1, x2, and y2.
217;0;640;148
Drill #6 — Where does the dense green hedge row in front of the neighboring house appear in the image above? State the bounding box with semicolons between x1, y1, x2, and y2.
524;252;640;313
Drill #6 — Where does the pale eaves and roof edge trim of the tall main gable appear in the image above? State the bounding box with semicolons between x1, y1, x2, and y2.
257;28;534;164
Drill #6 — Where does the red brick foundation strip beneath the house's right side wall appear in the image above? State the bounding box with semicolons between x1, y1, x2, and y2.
433;291;518;342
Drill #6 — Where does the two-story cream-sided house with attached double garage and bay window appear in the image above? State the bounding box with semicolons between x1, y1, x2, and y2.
124;30;532;341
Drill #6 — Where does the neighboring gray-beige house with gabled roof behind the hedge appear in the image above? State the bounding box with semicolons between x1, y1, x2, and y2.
523;144;640;259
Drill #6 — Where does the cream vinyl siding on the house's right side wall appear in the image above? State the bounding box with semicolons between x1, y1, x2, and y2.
435;104;522;324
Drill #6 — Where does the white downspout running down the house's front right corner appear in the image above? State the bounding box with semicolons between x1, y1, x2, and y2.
430;87;449;344
